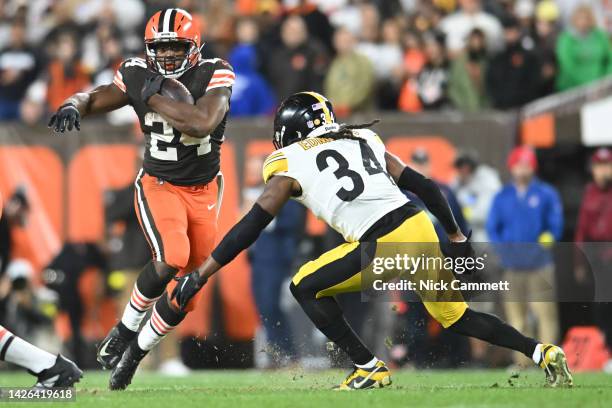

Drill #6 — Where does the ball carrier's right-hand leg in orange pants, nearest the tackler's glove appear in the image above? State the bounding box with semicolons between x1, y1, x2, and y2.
110;183;217;390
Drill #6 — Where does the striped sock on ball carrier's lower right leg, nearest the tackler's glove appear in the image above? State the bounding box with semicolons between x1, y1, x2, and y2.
138;296;186;351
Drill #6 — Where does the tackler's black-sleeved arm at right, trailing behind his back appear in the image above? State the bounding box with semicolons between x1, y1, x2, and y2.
385;152;466;242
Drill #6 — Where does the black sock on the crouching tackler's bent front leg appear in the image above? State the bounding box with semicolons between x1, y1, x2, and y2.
290;283;374;365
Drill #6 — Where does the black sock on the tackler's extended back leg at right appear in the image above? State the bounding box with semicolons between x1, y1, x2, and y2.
448;308;538;358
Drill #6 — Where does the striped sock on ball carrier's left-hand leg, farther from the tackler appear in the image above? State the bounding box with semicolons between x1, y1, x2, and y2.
121;262;168;332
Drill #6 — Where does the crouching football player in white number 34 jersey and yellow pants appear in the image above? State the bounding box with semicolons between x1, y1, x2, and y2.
172;92;572;389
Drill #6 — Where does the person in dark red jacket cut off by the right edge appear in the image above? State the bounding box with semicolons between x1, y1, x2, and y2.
574;147;612;372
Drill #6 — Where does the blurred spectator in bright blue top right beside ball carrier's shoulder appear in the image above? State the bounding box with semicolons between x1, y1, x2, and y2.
229;19;276;117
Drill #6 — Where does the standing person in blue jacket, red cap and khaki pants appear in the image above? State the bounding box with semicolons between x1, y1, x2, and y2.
487;146;563;364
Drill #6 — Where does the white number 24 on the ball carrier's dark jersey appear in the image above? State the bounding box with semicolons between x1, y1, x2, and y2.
145;112;211;161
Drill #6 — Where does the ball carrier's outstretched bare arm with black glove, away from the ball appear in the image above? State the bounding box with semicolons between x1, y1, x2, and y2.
48;84;129;133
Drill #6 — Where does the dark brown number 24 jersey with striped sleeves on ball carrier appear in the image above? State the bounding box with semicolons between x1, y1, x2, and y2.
113;58;235;186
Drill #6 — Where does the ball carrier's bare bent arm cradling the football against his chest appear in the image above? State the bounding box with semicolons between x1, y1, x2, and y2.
147;85;231;138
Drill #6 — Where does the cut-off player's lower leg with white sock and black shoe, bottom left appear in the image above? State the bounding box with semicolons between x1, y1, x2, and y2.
0;326;83;388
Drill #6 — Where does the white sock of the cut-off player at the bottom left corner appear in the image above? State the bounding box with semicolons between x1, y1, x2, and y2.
0;326;57;374
